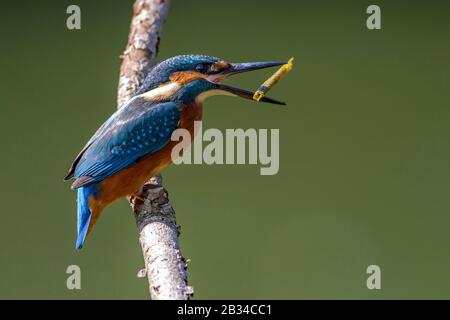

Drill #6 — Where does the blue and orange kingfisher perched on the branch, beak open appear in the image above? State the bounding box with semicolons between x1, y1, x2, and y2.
65;55;286;249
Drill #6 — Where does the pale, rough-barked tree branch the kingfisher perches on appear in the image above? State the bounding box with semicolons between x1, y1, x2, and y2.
117;0;193;300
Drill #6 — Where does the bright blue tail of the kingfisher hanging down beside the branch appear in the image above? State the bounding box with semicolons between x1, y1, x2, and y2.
75;183;98;250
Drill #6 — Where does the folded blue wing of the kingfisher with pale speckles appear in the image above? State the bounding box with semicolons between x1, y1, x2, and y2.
72;98;180;189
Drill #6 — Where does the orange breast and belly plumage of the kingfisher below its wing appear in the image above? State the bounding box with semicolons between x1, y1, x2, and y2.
96;104;202;208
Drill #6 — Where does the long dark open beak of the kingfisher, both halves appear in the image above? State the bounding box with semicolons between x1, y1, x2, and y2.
218;62;286;105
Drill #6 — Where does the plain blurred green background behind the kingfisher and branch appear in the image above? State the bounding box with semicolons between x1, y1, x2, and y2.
0;0;450;299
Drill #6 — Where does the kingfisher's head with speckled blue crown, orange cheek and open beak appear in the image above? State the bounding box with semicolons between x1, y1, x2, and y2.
137;55;285;104
